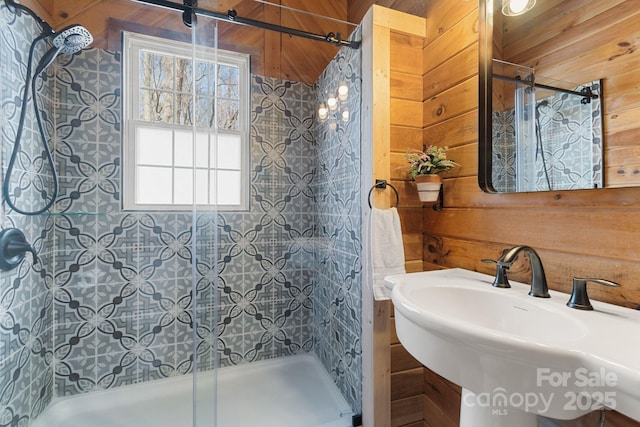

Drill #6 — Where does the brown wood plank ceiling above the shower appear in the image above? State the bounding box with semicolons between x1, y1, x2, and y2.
24;0;355;83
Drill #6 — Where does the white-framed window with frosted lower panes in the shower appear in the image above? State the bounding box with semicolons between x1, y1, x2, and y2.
123;33;249;210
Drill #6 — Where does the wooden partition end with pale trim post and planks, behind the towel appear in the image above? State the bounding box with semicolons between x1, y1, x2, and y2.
363;6;425;427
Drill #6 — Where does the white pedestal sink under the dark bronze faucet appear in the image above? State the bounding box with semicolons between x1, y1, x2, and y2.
385;269;640;426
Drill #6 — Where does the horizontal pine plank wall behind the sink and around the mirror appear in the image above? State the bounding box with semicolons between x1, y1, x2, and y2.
423;0;640;426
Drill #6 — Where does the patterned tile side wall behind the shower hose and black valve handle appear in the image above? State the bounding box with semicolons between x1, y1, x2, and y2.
0;2;53;426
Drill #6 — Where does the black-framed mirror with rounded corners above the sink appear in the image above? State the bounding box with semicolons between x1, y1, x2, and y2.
478;0;640;193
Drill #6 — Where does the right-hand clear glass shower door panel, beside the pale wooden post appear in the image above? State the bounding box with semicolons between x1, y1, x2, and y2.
192;1;361;427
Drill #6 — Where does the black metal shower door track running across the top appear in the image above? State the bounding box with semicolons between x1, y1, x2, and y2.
134;0;360;49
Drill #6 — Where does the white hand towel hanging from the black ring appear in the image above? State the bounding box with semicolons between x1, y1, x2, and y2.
371;208;405;300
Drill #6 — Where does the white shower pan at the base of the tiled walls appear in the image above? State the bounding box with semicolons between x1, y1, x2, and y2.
32;355;352;427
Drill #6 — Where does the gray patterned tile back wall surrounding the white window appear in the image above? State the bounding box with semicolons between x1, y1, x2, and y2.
54;49;322;395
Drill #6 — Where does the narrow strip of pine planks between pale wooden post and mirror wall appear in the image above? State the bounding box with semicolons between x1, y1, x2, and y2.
389;27;426;427
